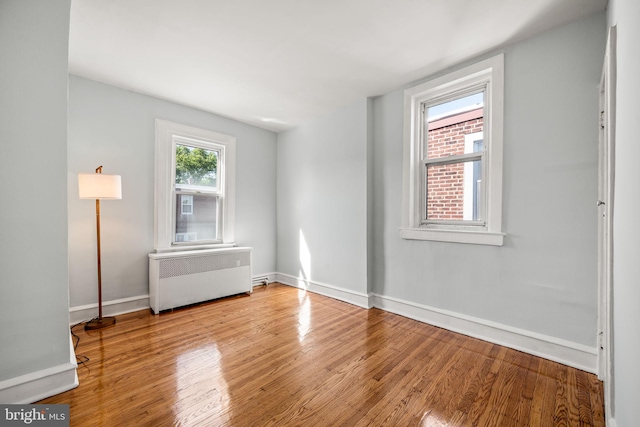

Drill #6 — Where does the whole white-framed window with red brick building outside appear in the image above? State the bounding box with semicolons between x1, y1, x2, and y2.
400;55;504;246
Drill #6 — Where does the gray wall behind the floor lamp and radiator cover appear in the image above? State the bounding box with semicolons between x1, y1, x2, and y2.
68;76;276;307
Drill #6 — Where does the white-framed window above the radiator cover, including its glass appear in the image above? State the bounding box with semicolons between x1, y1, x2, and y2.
154;120;235;252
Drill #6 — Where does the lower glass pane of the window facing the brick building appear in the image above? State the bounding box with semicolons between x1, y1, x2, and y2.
426;160;482;221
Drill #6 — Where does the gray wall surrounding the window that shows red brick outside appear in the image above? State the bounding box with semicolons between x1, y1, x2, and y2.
373;14;605;347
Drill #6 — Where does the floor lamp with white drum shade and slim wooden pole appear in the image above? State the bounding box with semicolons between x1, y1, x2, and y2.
78;166;122;330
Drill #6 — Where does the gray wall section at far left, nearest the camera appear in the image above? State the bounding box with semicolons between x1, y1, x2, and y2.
0;0;70;381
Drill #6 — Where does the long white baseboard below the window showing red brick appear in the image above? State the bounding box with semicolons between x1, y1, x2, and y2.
371;294;598;374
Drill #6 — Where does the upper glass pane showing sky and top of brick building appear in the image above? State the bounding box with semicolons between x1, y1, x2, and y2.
425;92;484;159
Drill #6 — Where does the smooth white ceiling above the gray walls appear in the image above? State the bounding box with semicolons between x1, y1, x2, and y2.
69;0;607;132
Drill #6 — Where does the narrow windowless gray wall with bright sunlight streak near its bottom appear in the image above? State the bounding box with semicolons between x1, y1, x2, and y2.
277;99;369;293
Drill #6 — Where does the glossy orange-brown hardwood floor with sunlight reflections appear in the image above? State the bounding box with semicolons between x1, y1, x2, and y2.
38;284;605;427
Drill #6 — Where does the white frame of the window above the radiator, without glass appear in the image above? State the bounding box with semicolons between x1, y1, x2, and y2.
154;119;236;252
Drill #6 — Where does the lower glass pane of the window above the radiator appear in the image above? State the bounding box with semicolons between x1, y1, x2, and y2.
175;194;218;242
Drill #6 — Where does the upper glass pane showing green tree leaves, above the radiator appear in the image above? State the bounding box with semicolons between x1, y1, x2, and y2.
176;144;218;189
